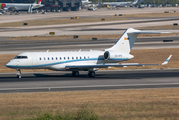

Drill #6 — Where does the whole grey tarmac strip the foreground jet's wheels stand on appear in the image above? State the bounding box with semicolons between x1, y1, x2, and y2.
0;69;179;93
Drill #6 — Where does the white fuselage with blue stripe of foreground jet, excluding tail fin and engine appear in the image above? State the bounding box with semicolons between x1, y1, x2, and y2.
6;50;133;71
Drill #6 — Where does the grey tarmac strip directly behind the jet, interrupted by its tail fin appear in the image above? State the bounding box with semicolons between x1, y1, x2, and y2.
0;36;179;54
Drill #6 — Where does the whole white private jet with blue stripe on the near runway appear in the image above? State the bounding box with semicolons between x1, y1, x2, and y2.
6;28;172;78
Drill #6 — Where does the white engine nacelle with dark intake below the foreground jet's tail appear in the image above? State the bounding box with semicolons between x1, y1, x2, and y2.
103;51;134;61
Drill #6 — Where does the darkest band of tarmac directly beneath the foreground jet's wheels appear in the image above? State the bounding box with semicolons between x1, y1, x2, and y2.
0;71;179;83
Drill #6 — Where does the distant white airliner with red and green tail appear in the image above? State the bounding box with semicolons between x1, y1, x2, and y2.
0;0;44;12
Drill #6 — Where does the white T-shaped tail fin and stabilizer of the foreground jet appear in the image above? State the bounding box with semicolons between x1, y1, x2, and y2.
105;28;168;54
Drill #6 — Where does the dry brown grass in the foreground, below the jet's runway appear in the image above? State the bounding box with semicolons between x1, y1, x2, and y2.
0;88;179;120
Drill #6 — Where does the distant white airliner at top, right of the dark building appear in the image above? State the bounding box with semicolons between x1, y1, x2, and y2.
103;0;138;7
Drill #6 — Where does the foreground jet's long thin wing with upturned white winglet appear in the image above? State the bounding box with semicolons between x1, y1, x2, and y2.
65;55;172;70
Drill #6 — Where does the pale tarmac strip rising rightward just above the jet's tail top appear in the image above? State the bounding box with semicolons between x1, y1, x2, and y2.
0;17;179;37
